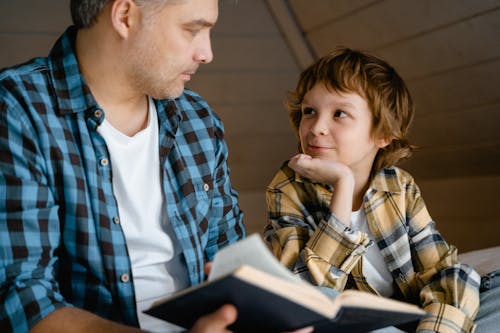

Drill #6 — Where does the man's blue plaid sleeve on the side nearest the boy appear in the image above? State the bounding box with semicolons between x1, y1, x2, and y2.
201;110;246;261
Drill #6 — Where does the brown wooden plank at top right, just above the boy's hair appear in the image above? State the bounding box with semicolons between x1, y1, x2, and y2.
306;0;499;55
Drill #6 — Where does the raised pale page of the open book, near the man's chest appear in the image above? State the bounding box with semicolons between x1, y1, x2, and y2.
208;234;305;283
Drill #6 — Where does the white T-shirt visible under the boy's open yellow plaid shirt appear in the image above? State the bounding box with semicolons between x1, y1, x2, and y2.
351;208;394;297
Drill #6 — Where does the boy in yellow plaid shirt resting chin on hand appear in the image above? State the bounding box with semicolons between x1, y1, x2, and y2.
265;48;488;332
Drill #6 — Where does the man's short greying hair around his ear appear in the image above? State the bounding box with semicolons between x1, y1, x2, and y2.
70;0;172;28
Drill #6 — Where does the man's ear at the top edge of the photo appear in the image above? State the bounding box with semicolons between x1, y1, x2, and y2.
111;0;140;38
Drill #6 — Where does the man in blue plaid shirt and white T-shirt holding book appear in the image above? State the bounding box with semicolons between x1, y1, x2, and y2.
0;0;245;332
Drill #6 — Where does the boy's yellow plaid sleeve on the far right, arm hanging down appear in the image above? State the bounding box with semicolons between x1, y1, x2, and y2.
406;175;480;333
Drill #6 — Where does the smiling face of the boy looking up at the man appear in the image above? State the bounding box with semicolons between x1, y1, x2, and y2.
299;83;384;173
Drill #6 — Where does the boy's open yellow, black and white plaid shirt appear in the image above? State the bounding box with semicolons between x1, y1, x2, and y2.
265;163;480;333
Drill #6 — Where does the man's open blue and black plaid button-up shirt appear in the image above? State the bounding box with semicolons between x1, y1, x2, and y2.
0;27;245;332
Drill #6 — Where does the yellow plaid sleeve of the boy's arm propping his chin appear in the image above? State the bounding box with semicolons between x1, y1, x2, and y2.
264;170;371;290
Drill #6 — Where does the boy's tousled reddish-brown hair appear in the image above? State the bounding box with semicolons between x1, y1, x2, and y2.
286;47;414;175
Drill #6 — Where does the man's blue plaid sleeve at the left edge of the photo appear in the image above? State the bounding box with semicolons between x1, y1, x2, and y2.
0;86;69;332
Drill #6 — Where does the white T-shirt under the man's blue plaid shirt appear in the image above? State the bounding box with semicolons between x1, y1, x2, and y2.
98;99;188;332
